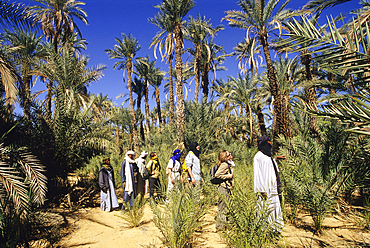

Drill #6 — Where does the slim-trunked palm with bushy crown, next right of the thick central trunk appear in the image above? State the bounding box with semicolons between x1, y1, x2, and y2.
184;14;224;102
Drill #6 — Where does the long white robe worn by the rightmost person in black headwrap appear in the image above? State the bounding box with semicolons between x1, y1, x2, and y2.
253;151;284;231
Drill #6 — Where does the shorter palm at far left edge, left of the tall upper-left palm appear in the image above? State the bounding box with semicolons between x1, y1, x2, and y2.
3;29;42;119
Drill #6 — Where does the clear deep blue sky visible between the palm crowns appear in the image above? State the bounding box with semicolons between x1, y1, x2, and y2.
17;0;360;108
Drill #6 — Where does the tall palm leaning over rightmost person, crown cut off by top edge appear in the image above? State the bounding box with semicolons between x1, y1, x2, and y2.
223;0;292;152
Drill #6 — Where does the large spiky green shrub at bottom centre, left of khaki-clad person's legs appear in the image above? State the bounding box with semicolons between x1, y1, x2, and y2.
151;183;208;248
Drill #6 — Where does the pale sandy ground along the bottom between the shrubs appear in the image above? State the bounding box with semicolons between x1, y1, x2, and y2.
30;187;370;248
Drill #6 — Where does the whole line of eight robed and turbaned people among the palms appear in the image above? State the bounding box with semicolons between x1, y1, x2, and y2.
99;138;284;231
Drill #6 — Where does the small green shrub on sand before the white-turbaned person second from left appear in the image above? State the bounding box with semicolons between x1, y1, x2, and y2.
118;197;148;227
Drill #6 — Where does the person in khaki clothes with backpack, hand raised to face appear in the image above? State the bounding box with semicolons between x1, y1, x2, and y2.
215;150;234;231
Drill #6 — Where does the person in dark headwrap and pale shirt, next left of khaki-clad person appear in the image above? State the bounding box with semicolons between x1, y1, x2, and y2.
185;142;204;186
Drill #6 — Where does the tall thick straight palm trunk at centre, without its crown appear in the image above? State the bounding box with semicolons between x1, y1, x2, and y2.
174;23;185;144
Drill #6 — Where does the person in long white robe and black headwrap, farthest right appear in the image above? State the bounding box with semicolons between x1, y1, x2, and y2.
253;134;284;231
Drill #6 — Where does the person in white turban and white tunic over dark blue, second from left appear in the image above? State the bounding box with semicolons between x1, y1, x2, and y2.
121;151;139;209
